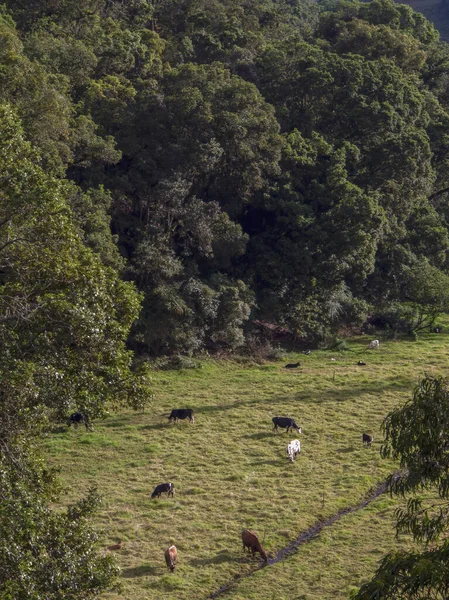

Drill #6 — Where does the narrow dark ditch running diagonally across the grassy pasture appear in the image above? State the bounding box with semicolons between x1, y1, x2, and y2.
208;471;399;599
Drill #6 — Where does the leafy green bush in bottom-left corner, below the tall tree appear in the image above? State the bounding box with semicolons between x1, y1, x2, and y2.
0;445;119;600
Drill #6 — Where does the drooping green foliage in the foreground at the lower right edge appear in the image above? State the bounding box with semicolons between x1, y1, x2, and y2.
353;377;449;600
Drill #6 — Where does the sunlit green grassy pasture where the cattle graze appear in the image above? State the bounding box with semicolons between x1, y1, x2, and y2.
46;333;449;600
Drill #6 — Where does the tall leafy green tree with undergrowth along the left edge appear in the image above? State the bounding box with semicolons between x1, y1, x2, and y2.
0;105;148;600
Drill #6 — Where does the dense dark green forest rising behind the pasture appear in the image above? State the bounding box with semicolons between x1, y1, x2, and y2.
1;0;449;356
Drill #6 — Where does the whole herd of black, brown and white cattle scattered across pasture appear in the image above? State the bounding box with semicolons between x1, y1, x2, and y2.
68;340;380;572
